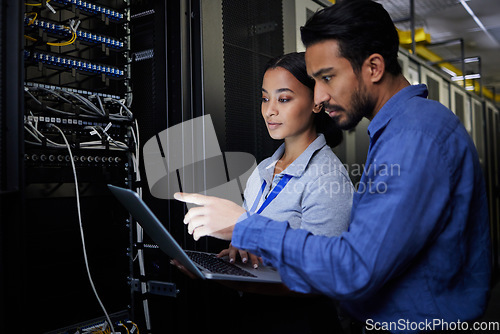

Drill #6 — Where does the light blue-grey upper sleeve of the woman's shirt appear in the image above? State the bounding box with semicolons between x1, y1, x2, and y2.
300;169;354;236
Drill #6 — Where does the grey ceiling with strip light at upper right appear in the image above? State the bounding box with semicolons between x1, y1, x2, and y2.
376;0;500;101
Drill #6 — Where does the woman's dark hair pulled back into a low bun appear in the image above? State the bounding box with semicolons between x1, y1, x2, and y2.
264;52;343;147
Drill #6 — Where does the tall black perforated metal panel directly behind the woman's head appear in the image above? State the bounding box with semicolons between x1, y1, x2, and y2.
222;0;283;161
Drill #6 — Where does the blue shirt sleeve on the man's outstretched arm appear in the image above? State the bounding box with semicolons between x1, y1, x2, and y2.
232;130;450;300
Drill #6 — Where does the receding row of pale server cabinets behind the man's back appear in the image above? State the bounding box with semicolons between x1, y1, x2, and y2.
399;50;500;283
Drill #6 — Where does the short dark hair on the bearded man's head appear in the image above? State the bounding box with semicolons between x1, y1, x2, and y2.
300;0;401;75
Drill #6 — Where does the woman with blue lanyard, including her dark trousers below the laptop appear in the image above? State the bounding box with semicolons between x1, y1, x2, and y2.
219;53;354;334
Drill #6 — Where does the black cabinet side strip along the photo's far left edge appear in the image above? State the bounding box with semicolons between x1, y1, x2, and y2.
0;0;24;333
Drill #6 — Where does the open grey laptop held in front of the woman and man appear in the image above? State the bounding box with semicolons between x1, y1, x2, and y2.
108;184;281;283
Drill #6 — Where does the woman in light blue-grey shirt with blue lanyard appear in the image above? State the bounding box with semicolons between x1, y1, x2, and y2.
219;53;354;267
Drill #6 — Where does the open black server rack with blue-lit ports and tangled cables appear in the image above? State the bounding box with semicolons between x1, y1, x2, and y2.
8;0;138;333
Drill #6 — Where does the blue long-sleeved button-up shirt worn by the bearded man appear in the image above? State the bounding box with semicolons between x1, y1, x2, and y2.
232;85;490;332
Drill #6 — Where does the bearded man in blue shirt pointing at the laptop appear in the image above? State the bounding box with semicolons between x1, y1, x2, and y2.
177;0;490;333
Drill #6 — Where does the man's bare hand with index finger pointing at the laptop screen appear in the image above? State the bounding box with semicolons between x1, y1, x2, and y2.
174;193;245;240
